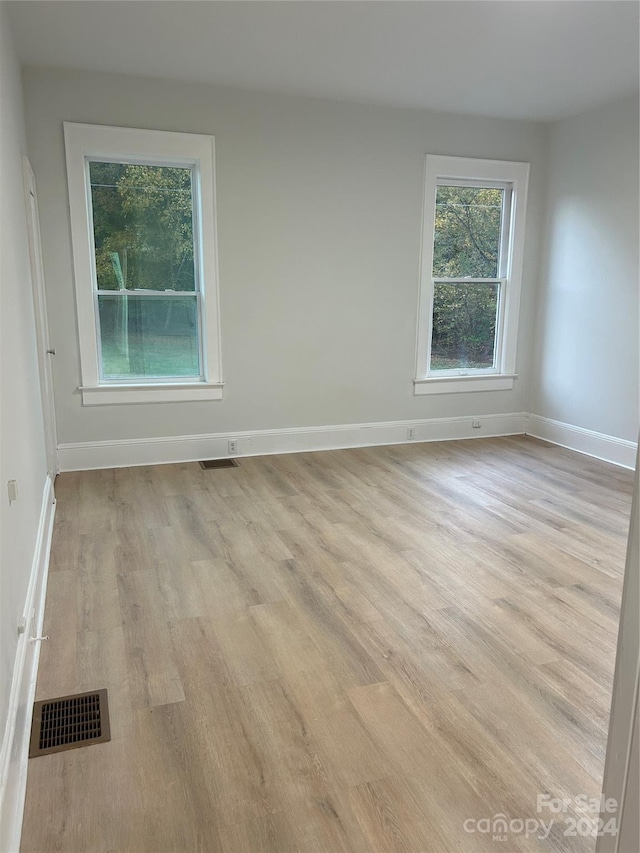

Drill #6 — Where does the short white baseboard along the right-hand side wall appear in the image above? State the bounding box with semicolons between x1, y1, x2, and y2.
526;414;638;470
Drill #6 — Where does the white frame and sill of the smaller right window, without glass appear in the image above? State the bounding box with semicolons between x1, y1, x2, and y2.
413;154;529;395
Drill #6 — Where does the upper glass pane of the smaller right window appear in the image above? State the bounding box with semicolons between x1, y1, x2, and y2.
433;187;504;278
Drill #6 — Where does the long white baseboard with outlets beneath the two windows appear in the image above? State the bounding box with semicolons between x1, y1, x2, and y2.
58;412;526;471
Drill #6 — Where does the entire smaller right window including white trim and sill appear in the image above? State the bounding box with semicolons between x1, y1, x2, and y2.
414;156;529;394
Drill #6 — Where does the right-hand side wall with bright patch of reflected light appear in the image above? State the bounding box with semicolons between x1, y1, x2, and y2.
530;96;639;441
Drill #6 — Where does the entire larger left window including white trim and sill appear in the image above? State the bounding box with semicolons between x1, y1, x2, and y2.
65;123;222;405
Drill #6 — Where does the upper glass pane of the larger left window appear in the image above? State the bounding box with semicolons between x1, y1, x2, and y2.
89;162;196;291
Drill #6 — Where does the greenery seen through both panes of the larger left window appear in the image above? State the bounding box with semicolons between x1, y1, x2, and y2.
89;161;201;379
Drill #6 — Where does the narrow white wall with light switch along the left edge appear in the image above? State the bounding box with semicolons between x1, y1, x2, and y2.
0;4;47;782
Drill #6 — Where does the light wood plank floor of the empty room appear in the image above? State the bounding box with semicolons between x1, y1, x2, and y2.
22;437;632;853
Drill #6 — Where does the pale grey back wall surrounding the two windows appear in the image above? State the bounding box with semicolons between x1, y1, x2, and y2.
24;69;545;443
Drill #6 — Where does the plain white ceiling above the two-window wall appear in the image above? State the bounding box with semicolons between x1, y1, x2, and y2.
9;0;639;120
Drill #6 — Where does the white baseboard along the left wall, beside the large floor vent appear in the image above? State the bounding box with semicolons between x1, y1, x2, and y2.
0;476;55;853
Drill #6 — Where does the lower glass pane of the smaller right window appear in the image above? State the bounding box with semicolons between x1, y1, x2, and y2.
431;283;500;370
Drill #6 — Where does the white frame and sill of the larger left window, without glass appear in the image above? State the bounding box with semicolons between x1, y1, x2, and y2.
64;122;224;406
